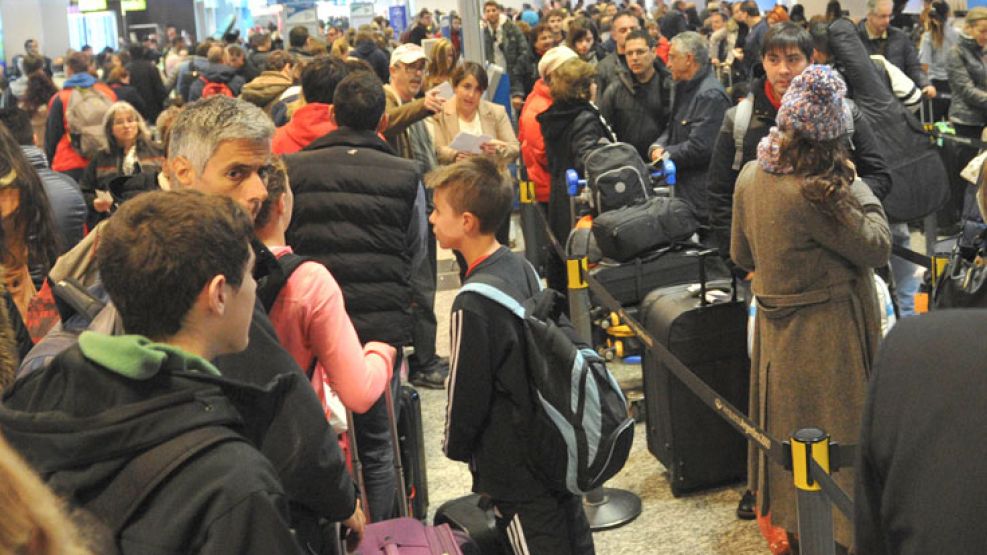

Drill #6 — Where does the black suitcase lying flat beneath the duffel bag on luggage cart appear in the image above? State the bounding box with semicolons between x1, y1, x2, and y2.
590;245;730;306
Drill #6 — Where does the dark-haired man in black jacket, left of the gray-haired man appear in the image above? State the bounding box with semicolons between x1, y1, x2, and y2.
600;29;671;159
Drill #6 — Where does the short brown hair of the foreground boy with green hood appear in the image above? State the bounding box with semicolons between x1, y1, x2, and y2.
96;190;253;340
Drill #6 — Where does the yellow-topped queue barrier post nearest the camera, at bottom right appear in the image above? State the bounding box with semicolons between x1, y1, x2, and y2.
791;428;836;555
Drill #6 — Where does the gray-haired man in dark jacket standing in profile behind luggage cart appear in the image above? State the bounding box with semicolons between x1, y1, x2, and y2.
650;31;730;223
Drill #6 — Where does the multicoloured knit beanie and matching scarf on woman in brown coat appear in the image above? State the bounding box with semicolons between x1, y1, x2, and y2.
757;65;846;173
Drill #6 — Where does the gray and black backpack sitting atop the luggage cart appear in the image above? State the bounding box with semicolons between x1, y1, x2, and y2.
583;142;654;214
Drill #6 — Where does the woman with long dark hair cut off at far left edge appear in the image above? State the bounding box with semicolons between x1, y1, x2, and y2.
0;125;60;319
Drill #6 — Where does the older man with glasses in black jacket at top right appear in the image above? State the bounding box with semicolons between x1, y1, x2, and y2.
857;0;936;98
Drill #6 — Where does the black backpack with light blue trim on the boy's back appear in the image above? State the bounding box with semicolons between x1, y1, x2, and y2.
460;275;634;495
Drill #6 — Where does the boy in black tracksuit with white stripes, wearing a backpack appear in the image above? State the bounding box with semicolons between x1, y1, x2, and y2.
428;156;594;555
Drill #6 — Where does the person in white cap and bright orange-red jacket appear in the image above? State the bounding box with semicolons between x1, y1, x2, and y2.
518;46;580;204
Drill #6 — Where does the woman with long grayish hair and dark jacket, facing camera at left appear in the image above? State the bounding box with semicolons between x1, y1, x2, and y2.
79;102;164;229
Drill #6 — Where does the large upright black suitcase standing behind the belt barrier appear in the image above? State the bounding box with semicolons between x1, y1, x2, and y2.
641;251;750;497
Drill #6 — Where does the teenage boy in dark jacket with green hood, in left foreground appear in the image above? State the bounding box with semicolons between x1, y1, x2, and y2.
0;191;312;554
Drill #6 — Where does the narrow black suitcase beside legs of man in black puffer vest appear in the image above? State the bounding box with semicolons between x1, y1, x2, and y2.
398;385;428;521
